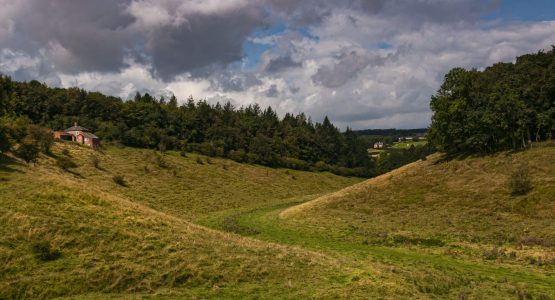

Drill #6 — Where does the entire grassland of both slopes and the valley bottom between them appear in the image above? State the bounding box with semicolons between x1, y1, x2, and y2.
0;144;555;299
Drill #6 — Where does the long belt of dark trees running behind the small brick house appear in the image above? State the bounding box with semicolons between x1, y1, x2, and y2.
0;76;375;177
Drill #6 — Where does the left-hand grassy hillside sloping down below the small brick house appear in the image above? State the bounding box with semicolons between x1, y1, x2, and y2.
0;145;364;298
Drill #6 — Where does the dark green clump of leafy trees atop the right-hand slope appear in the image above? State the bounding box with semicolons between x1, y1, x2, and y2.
429;46;555;153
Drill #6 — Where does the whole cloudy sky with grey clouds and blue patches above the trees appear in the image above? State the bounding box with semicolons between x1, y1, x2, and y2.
0;0;555;129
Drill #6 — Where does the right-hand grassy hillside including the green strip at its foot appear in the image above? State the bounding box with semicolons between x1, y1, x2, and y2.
276;144;555;298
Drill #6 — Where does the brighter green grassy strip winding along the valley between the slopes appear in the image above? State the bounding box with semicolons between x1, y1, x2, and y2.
205;196;555;299
